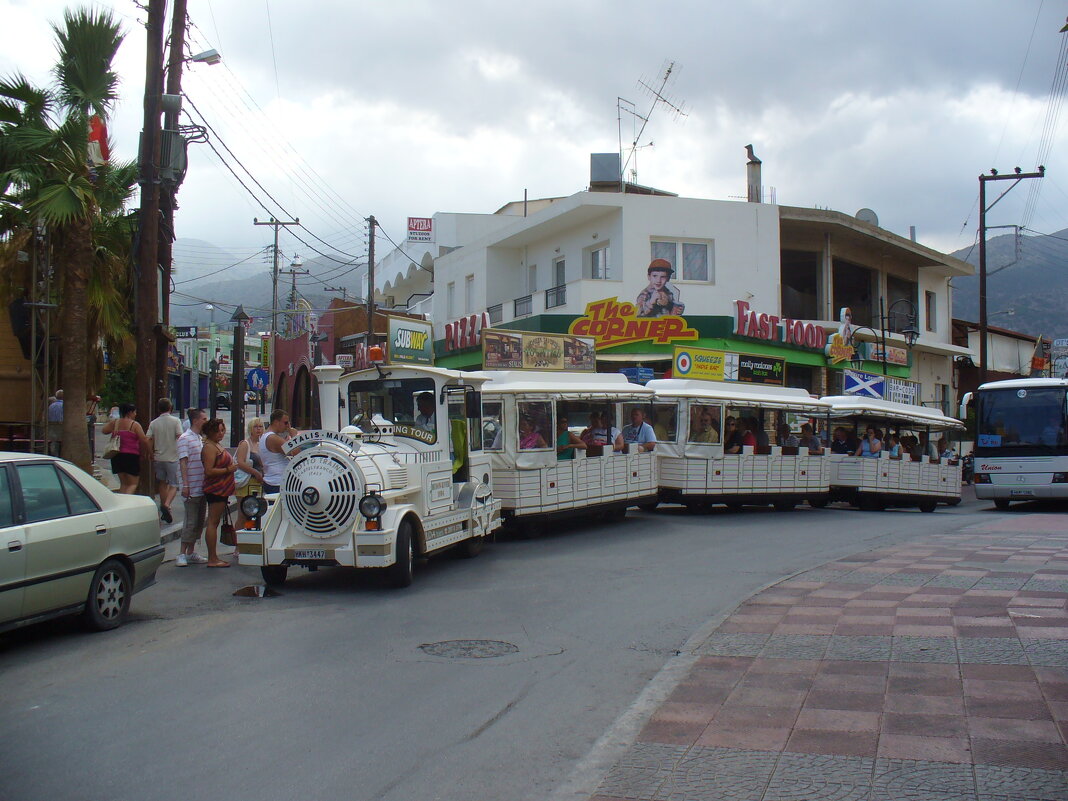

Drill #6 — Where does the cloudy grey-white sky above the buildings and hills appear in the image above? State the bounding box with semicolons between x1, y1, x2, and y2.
0;0;1068;279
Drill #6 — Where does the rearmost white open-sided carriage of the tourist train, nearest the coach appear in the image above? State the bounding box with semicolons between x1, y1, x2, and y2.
823;395;963;512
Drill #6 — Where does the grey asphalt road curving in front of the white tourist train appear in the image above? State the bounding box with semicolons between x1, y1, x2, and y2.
0;502;1018;801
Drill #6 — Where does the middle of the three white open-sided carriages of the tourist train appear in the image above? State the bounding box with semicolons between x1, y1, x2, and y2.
646;378;831;511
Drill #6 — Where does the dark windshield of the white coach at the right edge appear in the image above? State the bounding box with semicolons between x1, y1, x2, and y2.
975;387;1068;456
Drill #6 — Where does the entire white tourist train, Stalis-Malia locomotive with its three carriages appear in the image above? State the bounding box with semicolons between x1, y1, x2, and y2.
238;356;962;586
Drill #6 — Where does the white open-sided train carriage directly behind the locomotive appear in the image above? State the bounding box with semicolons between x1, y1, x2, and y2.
467;370;657;533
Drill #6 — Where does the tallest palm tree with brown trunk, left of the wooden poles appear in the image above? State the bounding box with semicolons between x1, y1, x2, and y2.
0;9;123;469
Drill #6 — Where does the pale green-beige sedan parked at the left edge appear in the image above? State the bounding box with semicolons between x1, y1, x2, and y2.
0;452;163;631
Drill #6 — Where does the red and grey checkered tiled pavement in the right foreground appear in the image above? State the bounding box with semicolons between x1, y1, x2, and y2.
594;515;1068;801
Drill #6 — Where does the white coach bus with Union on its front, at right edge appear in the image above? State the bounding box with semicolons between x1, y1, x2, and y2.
961;378;1068;509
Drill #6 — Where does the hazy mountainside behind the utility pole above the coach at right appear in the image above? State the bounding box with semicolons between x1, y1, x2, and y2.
953;229;1068;339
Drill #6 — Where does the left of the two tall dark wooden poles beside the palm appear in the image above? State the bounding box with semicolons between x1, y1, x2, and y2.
135;0;167;482
